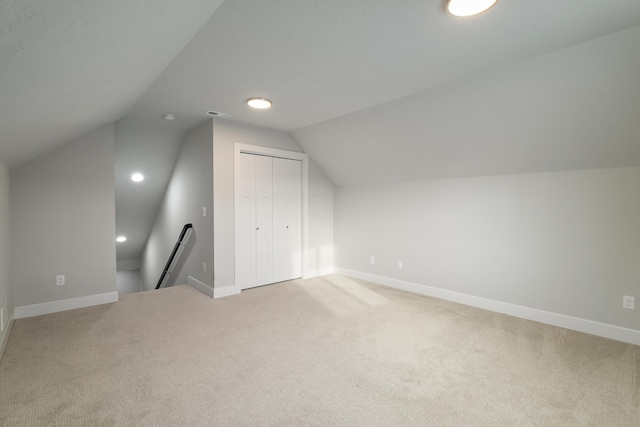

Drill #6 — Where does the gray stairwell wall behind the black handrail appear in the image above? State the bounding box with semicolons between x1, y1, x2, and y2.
140;121;213;290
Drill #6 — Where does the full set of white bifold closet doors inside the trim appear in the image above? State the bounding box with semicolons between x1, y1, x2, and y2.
235;153;302;289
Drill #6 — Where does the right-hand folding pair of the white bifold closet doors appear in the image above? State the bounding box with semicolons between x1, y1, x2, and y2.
273;158;302;282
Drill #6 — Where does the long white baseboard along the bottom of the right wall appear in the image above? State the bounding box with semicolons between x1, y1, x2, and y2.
334;267;640;345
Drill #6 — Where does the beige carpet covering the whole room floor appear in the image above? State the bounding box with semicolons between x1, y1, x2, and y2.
0;275;640;426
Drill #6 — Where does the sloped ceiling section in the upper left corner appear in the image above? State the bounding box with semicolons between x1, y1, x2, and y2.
0;0;222;167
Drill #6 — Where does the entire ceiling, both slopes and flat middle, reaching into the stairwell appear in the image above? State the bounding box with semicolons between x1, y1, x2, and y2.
0;0;640;258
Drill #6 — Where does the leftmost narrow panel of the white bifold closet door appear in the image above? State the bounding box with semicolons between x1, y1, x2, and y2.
235;153;257;289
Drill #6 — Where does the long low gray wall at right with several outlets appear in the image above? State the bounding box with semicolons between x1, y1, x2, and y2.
335;168;640;330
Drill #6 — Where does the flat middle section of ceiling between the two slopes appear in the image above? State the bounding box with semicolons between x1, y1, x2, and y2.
129;0;640;135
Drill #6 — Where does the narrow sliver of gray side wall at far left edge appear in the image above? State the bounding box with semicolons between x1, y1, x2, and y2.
0;163;13;359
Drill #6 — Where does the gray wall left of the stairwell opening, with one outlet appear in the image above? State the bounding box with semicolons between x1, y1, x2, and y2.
10;124;116;307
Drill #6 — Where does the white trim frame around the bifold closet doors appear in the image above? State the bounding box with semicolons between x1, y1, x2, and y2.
233;142;309;293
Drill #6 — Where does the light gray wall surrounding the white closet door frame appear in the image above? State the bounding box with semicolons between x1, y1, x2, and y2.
213;119;333;288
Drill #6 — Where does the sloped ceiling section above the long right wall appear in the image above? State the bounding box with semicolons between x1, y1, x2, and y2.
292;27;640;186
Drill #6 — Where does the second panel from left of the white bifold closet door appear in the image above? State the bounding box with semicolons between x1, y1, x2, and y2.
255;156;274;286
